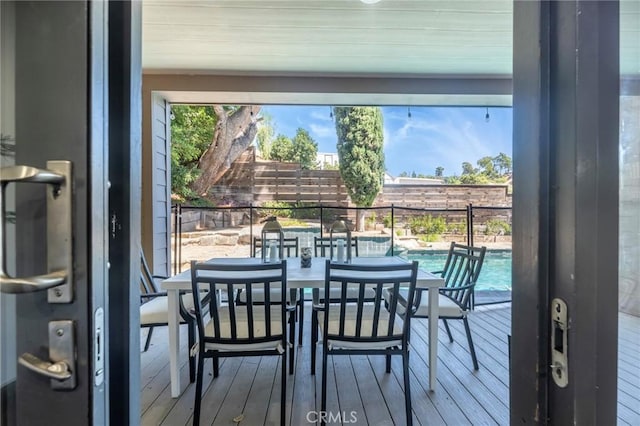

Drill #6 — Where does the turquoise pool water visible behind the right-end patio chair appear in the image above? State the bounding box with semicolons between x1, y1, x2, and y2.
403;250;511;291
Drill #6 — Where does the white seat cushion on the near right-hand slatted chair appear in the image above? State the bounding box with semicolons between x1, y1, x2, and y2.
318;305;403;349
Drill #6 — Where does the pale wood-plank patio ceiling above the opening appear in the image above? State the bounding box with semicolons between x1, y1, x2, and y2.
143;0;513;78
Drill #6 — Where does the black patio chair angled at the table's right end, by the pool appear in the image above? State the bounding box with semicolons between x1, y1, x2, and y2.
385;242;487;370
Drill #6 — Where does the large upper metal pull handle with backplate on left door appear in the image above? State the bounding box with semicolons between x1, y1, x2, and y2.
0;161;73;303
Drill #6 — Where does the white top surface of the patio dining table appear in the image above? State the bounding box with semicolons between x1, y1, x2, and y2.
162;256;444;290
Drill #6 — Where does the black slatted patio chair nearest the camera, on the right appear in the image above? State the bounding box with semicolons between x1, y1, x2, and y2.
311;260;418;425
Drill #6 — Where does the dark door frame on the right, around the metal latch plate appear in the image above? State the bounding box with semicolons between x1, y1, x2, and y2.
510;0;620;424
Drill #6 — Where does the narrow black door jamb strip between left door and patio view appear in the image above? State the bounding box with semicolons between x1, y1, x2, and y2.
108;0;142;425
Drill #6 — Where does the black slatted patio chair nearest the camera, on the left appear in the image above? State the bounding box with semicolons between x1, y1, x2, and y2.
191;260;295;425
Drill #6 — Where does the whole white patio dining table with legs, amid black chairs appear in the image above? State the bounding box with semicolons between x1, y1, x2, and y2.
162;257;444;398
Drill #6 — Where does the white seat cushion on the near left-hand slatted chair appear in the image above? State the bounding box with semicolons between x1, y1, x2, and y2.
204;306;288;352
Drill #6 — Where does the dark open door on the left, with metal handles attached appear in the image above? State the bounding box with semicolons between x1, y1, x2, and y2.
15;1;109;425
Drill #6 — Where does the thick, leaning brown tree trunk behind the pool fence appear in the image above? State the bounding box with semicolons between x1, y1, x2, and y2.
192;105;261;197
